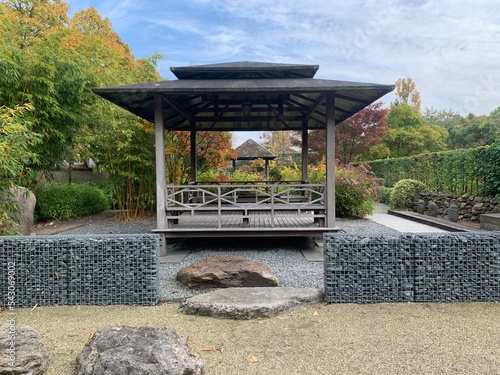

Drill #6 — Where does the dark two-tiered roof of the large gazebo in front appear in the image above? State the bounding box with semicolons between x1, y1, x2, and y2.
93;62;394;131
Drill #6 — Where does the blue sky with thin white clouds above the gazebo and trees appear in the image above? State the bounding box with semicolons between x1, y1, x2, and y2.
66;0;500;147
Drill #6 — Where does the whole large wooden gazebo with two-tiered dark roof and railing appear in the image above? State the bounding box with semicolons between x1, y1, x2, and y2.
94;62;394;255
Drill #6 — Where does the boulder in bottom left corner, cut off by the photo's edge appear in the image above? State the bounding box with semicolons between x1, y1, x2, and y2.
0;321;49;375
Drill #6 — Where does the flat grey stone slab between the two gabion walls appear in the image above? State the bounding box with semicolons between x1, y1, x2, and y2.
179;287;324;319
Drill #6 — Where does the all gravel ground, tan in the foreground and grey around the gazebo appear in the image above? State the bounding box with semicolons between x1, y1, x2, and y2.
10;213;500;375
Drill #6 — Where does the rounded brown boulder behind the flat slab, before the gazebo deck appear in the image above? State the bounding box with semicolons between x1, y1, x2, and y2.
177;255;279;289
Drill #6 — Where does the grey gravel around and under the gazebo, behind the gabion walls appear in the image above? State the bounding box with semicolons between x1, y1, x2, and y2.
61;219;397;301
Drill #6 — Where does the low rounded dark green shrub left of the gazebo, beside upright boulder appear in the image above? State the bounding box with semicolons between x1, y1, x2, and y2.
35;183;110;220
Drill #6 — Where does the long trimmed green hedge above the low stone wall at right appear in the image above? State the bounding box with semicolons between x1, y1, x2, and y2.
366;142;500;198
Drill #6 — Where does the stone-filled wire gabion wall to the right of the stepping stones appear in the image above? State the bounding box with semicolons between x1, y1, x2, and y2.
324;232;500;303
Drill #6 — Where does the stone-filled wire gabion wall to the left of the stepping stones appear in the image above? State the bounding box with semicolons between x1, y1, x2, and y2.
0;234;159;307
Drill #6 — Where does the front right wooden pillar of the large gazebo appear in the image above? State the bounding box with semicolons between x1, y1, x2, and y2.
326;92;335;228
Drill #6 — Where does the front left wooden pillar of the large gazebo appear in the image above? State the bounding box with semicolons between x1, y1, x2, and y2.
155;94;167;256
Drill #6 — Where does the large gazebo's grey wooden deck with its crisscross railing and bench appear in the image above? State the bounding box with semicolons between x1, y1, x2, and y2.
155;184;337;238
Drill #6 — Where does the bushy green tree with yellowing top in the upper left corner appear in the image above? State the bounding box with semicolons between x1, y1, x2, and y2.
0;0;94;170
